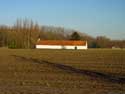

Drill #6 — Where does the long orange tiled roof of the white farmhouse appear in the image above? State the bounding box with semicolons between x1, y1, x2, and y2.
36;40;86;46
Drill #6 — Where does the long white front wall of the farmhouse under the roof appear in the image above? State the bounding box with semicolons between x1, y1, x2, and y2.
36;45;87;49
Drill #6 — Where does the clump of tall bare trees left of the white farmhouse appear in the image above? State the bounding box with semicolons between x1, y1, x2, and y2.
14;19;40;49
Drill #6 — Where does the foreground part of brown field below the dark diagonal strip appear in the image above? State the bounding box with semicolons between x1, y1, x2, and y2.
0;50;125;94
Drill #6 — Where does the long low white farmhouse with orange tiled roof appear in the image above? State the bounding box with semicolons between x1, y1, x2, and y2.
36;40;88;49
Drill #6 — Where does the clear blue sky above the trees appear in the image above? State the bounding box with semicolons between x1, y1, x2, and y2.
0;0;125;40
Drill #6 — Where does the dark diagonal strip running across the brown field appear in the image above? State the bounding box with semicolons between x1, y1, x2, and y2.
13;55;125;84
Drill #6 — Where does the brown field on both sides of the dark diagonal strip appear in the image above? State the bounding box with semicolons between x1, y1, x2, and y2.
0;48;125;94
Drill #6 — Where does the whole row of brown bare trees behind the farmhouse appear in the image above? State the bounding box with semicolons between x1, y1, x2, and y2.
0;19;125;49
